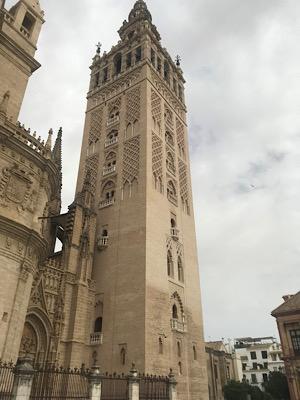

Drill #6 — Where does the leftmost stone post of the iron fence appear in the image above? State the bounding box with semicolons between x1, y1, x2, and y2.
12;358;34;400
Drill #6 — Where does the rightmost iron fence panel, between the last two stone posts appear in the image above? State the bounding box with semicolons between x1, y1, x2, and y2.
140;375;169;400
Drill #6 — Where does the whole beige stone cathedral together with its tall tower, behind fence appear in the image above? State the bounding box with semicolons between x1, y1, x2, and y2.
0;0;208;400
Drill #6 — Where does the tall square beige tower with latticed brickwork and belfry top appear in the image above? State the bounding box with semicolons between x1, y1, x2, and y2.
69;0;208;400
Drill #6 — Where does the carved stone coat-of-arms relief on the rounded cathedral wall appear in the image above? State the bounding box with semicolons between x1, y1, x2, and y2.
0;165;36;212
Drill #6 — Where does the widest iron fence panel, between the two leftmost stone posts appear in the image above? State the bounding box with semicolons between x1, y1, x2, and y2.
30;368;89;400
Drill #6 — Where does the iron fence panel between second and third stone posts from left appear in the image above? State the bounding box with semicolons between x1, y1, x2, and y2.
101;374;129;400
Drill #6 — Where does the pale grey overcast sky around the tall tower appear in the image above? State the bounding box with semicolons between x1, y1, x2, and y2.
7;0;300;340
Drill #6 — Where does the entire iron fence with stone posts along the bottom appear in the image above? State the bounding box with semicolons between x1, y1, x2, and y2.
0;359;176;400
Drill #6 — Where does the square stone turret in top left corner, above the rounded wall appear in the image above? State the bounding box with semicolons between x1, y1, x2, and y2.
0;0;44;122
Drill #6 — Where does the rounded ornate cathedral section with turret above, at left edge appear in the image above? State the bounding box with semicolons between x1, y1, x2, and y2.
0;0;61;361
